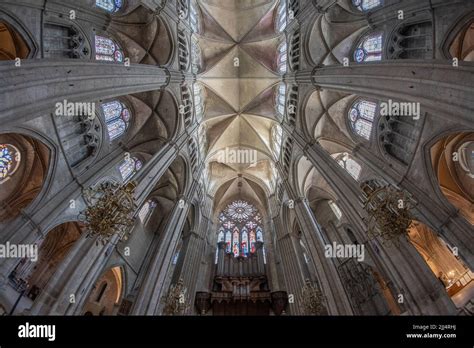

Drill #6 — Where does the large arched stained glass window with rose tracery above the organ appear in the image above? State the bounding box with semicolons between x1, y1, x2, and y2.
217;200;263;257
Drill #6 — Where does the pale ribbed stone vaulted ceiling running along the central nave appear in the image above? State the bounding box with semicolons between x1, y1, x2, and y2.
195;0;282;209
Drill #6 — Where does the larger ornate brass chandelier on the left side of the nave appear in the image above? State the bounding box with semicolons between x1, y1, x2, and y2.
79;182;137;244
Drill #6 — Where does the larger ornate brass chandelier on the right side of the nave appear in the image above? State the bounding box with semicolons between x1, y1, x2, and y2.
362;182;416;245
